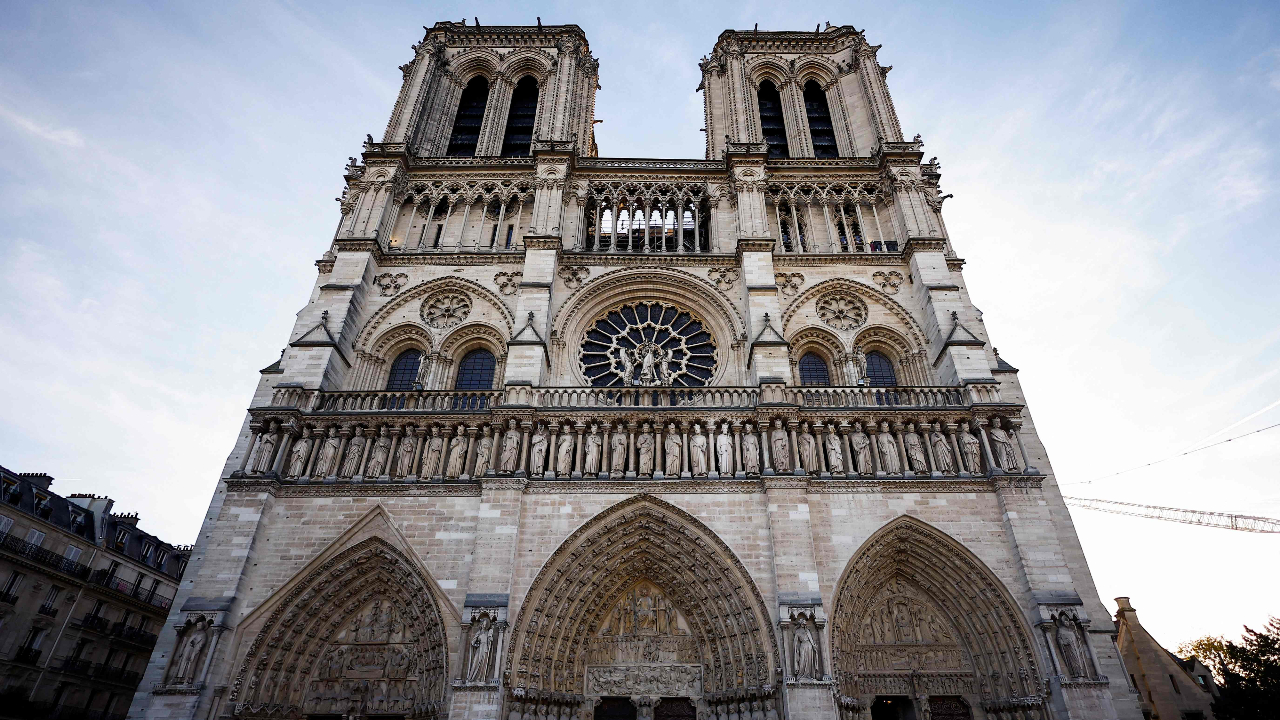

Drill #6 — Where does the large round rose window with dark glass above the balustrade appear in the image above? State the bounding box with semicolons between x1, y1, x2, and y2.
579;302;716;387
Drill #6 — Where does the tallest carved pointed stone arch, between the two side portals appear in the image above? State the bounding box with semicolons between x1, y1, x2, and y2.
506;495;781;694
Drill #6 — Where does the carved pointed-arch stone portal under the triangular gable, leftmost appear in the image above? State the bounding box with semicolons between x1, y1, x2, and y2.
229;537;448;717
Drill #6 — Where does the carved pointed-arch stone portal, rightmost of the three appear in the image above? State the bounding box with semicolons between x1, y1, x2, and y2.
831;515;1043;719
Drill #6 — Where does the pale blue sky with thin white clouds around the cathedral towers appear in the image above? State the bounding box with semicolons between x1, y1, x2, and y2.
0;0;1280;648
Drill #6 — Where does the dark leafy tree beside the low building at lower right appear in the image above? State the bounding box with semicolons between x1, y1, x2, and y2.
1197;618;1280;720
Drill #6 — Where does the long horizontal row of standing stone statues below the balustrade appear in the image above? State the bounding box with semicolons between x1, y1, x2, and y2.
241;418;1027;479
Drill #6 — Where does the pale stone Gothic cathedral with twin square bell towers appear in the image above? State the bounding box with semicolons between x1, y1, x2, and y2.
131;22;1140;720
